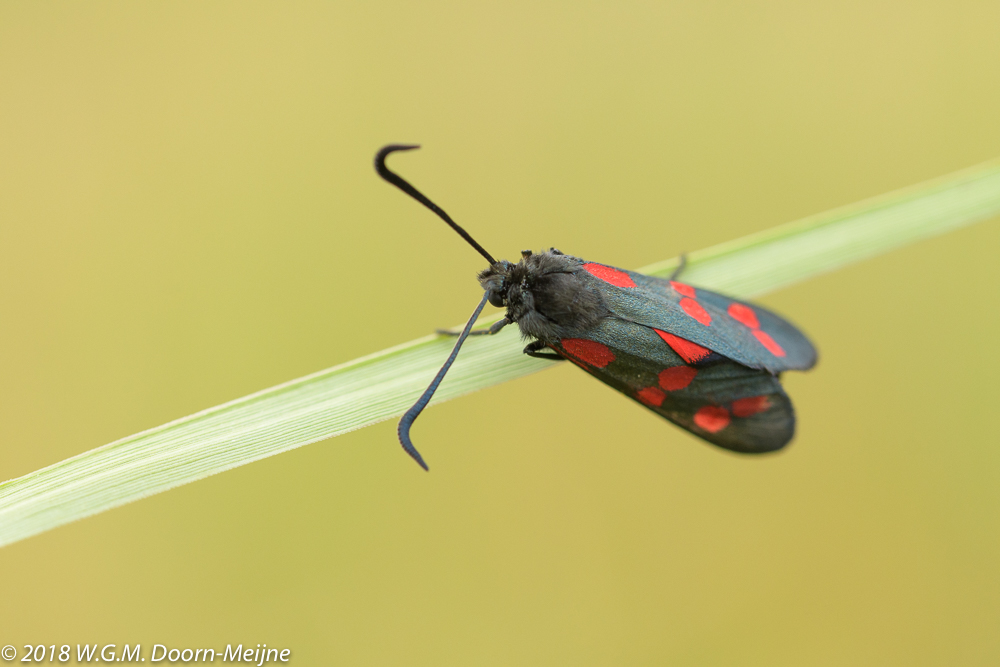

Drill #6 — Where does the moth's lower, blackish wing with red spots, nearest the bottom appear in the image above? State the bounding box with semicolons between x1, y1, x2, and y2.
552;318;795;453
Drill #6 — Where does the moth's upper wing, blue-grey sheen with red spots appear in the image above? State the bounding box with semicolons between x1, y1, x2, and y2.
580;262;816;373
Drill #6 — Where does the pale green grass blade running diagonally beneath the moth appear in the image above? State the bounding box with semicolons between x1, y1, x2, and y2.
0;162;1000;545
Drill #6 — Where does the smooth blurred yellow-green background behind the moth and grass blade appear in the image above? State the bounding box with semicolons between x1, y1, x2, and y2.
0;1;1000;665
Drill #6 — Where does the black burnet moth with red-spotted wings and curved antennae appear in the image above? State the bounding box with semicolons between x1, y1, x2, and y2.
375;144;816;470
